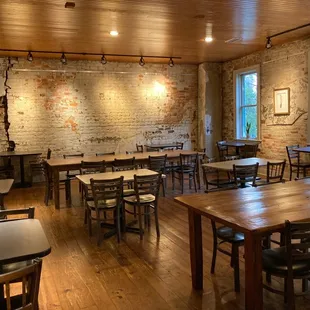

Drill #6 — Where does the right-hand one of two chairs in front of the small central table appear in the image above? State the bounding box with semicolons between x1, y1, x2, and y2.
124;173;162;240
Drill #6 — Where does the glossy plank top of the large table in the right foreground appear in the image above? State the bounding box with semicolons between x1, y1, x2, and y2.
175;179;310;234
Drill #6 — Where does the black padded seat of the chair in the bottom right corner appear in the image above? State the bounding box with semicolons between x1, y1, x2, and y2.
263;247;310;277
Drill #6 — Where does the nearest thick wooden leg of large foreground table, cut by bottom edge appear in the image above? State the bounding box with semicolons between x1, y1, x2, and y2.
244;233;263;310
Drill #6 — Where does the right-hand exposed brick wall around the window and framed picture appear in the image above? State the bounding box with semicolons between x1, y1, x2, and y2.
223;39;310;159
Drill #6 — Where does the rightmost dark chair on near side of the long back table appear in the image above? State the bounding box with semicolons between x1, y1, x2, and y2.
172;153;198;194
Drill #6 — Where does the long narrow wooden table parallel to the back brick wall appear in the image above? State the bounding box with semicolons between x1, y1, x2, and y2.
47;150;200;209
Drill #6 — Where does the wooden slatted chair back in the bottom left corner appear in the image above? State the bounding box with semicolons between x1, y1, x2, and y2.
0;259;42;310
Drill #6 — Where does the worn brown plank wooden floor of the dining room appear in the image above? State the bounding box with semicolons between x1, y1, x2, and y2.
5;178;310;310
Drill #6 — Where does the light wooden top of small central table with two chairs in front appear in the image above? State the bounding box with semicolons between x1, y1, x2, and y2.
76;169;158;185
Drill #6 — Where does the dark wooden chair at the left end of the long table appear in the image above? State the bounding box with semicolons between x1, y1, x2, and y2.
43;161;71;206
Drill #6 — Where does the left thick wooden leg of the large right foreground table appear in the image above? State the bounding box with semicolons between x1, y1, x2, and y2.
188;208;203;290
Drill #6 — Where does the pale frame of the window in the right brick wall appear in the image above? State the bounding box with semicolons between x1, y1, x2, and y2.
233;65;261;140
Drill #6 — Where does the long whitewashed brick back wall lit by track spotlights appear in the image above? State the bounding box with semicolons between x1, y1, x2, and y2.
0;59;197;156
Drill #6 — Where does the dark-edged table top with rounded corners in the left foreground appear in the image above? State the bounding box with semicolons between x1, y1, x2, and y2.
0;219;51;265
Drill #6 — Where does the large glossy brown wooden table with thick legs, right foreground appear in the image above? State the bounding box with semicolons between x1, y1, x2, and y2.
175;179;310;310
